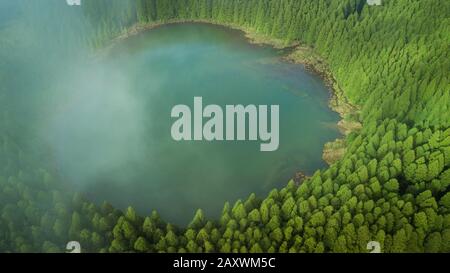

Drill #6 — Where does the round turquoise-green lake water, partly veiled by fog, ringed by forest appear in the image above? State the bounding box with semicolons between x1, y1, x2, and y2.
48;24;339;224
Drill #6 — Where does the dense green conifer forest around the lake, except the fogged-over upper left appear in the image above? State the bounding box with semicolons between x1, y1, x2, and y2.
0;0;450;253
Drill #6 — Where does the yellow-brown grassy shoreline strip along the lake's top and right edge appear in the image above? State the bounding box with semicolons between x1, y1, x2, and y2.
102;20;362;165
